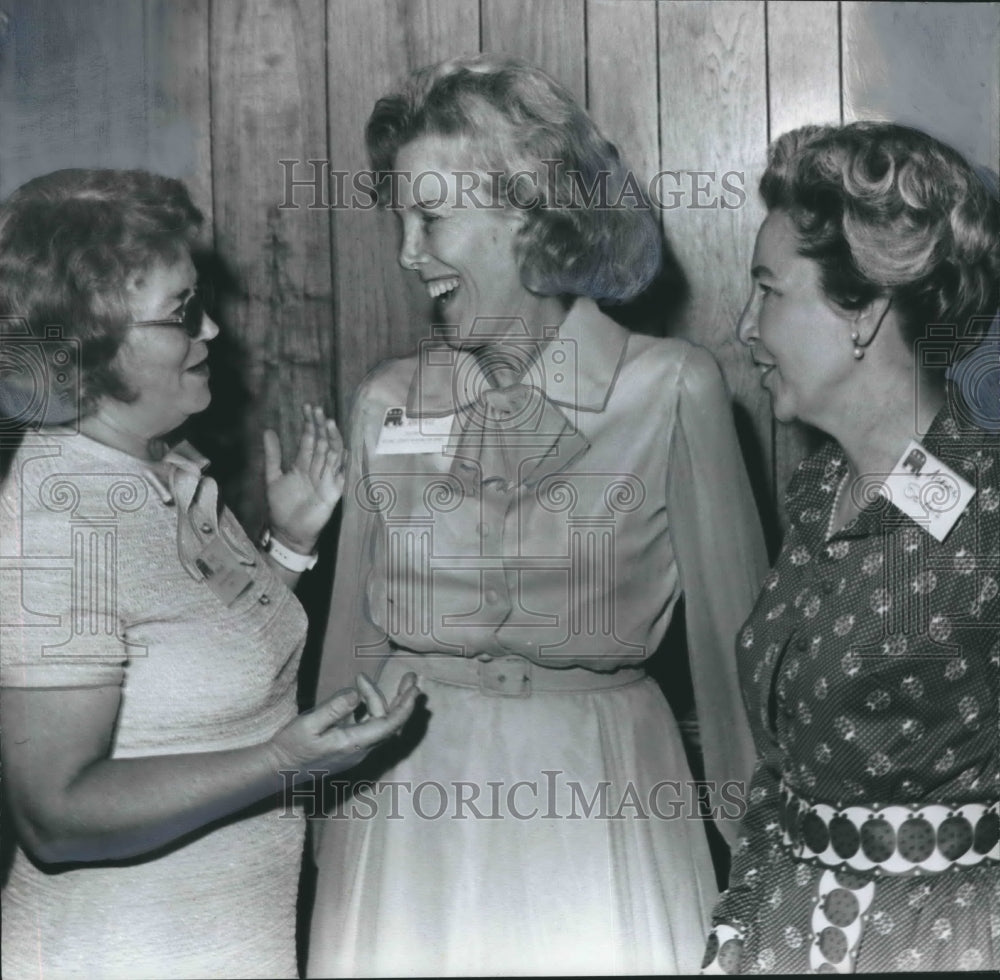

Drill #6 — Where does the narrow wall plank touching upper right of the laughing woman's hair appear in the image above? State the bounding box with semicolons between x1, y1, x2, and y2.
587;0;660;187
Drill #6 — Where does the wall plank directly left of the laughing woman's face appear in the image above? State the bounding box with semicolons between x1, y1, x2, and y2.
328;0;479;420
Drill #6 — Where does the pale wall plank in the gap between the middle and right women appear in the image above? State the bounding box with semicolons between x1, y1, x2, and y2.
659;0;773;534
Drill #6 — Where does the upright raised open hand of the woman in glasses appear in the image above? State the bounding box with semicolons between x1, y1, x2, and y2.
264;403;344;554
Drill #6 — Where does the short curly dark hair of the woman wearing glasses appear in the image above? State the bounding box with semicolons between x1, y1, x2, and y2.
0;169;202;415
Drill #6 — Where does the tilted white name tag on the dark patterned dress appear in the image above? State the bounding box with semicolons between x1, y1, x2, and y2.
879;440;976;541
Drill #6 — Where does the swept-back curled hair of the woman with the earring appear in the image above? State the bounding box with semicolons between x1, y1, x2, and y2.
760;122;1000;358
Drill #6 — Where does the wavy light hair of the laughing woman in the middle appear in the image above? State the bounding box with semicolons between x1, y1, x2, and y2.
365;54;661;302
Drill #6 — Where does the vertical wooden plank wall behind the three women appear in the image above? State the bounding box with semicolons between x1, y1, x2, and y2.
0;0;1000;544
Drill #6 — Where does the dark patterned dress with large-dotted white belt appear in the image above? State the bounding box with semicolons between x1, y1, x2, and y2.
704;393;1000;973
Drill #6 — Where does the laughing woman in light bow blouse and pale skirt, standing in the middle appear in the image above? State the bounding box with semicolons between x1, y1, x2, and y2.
309;56;764;976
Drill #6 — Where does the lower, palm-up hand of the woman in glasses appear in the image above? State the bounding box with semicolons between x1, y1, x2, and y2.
269;673;420;779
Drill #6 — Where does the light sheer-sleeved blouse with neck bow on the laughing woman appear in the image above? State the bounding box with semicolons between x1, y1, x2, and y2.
319;299;767;836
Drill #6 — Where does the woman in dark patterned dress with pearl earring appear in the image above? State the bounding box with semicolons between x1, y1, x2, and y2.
705;123;1000;973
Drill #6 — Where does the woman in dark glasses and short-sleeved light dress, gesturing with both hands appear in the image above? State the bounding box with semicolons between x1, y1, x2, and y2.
0;170;416;980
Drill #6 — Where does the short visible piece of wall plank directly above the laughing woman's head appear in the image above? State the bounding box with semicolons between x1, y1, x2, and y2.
482;0;587;105
